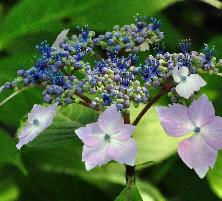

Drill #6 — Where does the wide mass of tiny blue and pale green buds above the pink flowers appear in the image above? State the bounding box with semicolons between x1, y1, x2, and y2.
2;16;220;110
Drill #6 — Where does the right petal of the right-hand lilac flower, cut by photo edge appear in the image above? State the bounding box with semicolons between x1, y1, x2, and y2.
201;117;222;150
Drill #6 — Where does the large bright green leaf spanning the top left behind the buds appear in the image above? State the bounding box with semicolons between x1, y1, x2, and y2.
0;0;179;49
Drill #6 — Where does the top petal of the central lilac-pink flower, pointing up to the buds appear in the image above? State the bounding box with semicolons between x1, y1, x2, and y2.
98;105;124;135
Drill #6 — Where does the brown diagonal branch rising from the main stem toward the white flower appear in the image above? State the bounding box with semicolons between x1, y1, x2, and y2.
133;83;173;126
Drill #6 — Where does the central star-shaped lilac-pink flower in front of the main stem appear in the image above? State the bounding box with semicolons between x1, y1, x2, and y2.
75;105;136;170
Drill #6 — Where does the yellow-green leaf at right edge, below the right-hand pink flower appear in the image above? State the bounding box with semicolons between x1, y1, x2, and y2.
207;152;222;199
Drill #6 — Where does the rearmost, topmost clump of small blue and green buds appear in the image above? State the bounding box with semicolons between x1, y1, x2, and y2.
93;15;164;52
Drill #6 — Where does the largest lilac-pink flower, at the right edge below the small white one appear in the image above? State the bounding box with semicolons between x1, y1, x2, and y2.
157;95;222;178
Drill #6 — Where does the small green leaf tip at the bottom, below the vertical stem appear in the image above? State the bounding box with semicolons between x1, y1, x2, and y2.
115;185;143;201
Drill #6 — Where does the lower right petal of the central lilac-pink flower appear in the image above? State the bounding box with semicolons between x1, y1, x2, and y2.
107;138;137;166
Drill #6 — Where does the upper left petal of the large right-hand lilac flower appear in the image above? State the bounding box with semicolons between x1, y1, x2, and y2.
156;104;194;137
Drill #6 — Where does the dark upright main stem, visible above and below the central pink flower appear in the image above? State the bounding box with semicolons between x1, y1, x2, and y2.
123;112;136;188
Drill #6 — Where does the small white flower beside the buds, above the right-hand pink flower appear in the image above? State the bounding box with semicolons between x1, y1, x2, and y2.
173;66;207;99
